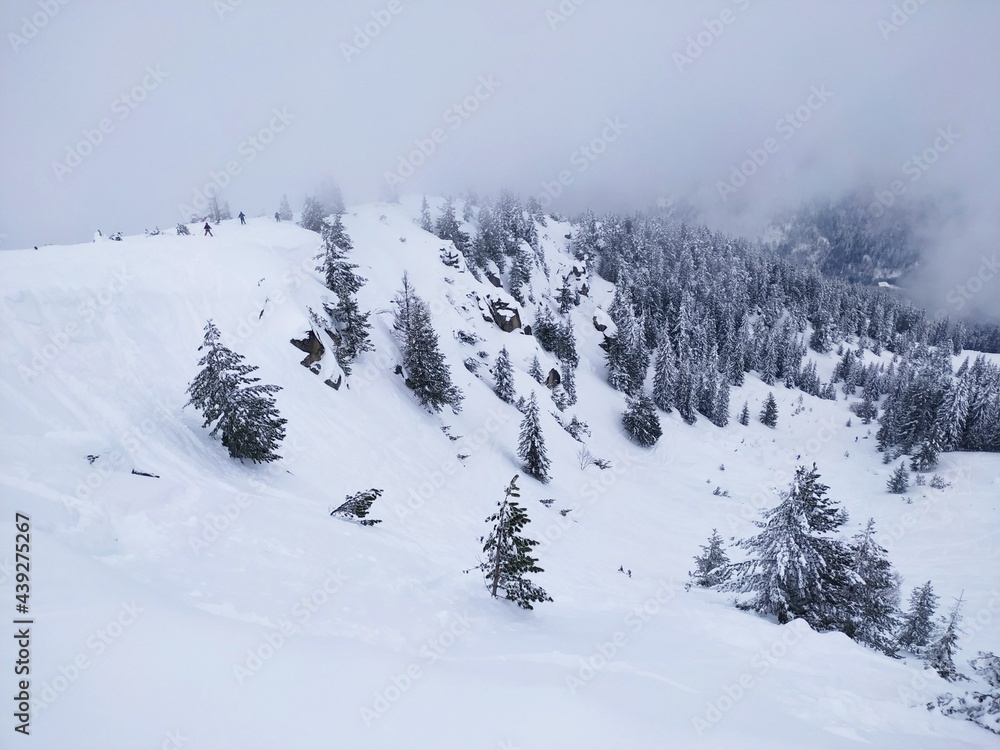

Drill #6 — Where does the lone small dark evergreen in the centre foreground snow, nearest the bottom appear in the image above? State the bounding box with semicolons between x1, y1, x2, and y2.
479;474;552;609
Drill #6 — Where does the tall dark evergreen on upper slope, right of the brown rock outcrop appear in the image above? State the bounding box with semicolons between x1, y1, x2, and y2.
394;273;464;411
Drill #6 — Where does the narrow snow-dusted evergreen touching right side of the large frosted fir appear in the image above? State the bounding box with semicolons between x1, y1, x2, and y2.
848;518;899;656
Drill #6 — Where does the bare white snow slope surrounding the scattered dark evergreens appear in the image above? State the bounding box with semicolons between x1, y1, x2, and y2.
0;204;1000;750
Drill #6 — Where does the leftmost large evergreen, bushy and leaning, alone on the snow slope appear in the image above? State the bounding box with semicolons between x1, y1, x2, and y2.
185;320;287;463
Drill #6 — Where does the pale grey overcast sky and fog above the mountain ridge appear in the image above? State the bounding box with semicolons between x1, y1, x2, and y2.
0;0;1000;318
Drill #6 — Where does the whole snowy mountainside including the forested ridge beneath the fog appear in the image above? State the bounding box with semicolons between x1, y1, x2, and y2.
0;195;1000;748
